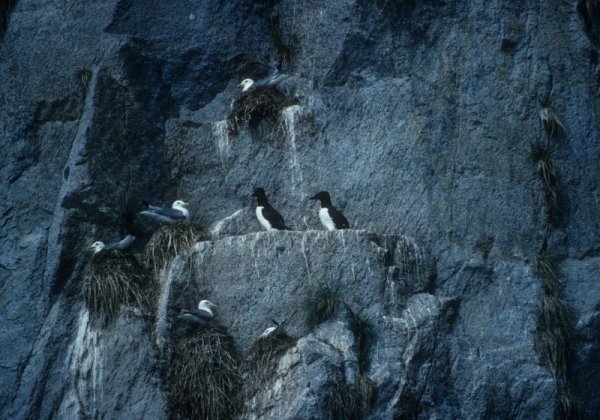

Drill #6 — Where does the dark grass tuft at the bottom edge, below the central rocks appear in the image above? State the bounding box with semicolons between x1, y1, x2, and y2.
325;377;375;420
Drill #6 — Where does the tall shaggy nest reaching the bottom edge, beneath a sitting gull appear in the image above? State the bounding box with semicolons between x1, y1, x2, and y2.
168;326;241;419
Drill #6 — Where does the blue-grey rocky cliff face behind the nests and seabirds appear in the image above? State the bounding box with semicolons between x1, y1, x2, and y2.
0;0;600;418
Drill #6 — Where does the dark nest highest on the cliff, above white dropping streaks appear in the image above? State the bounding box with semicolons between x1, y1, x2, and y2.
227;86;298;135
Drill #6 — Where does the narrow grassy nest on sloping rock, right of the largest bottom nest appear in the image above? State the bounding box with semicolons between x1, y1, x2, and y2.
242;336;298;401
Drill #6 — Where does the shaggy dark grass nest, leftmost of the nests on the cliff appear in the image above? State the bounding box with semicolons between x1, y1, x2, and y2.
81;250;152;320
